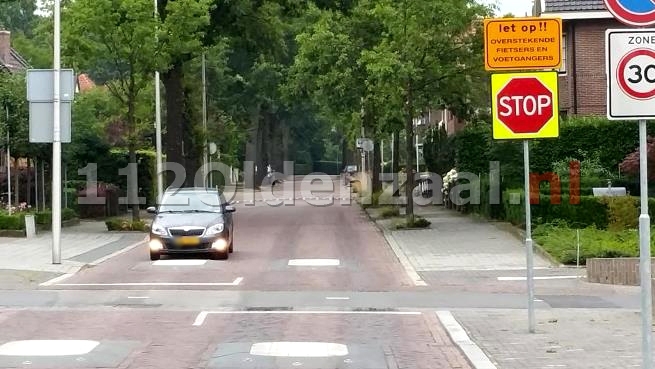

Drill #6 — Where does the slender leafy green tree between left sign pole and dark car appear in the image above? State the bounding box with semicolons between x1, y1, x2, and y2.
62;0;161;221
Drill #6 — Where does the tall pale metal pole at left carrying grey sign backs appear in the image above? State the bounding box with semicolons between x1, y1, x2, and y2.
52;0;61;264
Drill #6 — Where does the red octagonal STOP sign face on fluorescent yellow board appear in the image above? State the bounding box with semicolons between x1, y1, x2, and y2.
496;77;553;133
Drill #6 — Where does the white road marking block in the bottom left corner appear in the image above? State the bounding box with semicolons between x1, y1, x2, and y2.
0;340;100;356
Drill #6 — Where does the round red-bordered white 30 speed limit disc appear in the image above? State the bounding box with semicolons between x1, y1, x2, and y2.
616;49;655;100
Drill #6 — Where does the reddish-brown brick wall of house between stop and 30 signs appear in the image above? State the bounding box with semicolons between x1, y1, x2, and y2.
560;19;623;116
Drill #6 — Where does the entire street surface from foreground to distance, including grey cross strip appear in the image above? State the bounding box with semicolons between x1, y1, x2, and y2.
0;178;633;369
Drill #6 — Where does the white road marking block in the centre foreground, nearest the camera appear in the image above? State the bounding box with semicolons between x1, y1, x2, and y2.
250;342;348;357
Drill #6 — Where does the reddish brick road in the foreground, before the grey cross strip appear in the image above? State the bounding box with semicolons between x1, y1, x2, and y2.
0;309;471;369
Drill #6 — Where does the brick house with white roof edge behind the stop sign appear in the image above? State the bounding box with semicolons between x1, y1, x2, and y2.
533;0;625;116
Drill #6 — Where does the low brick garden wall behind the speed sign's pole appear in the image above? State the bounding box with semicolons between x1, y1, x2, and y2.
587;258;655;286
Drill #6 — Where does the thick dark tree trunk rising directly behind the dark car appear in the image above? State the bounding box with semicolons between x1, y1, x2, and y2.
162;63;186;188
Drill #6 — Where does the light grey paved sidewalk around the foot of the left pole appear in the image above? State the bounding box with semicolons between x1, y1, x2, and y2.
0;221;146;274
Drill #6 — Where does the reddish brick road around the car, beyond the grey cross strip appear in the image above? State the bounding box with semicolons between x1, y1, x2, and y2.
49;181;413;291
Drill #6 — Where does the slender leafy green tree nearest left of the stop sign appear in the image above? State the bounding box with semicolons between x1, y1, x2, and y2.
360;0;489;223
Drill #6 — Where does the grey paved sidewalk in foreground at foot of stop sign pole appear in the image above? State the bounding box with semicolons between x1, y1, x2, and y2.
453;309;652;369
